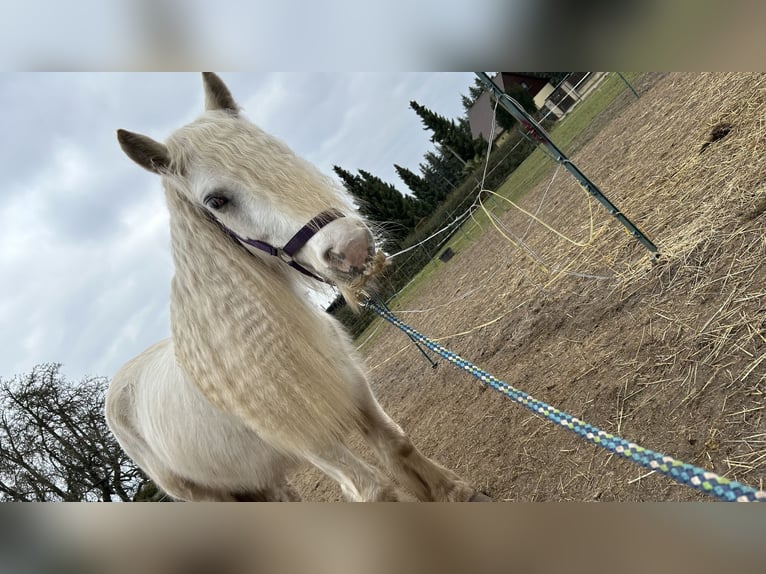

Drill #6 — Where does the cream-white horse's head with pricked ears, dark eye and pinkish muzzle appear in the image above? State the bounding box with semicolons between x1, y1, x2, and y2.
118;73;385;308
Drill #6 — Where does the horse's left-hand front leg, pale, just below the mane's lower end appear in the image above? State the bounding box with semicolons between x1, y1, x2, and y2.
306;444;400;502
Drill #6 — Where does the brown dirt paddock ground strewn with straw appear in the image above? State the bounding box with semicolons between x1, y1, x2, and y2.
295;74;766;501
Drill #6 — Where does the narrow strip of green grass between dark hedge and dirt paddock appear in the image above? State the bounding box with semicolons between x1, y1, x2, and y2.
357;72;640;342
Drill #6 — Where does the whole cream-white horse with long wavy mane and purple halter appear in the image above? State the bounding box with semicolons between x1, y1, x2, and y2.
105;73;490;501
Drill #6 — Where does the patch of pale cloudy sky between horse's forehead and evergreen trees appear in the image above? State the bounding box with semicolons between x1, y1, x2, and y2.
237;73;473;192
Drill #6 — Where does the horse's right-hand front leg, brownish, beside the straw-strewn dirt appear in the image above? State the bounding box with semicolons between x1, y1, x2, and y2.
362;394;492;502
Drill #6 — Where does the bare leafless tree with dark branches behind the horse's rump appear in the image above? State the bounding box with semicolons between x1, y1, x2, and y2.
0;363;149;502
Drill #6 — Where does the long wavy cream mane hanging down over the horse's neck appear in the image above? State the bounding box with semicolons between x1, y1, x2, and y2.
167;190;358;452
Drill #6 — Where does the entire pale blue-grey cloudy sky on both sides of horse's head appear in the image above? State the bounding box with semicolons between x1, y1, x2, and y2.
0;73;474;381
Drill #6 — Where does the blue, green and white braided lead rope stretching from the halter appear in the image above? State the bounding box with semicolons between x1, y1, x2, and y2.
366;301;766;502
